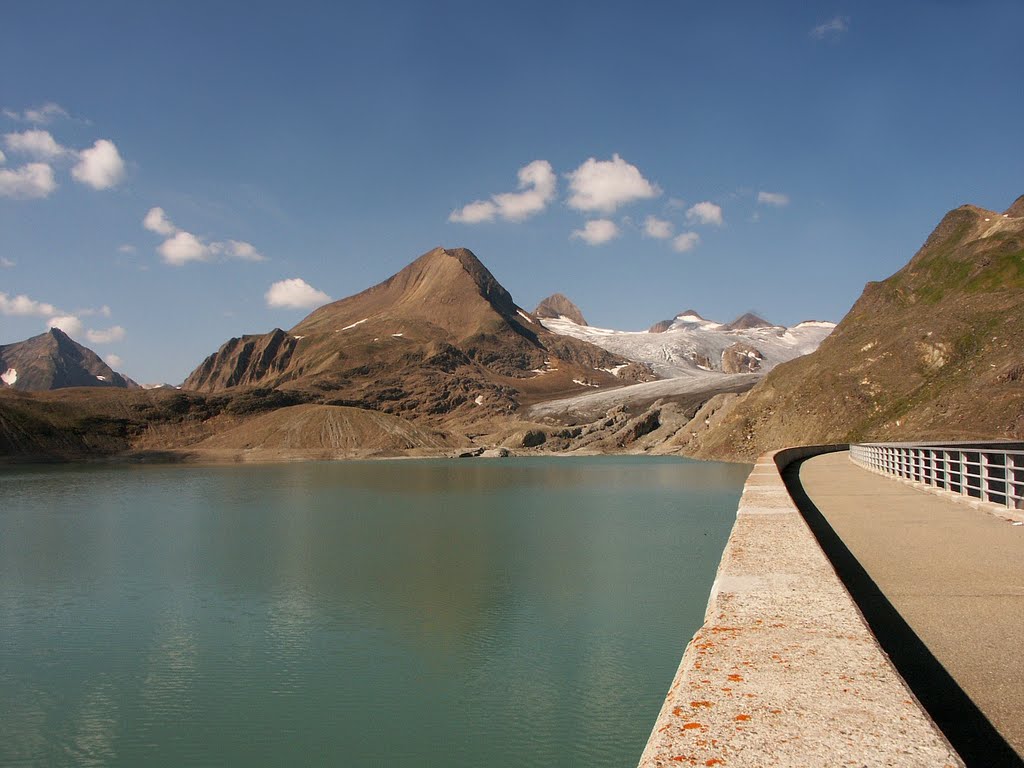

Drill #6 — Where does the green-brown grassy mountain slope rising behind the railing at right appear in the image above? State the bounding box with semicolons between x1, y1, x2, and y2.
684;197;1024;460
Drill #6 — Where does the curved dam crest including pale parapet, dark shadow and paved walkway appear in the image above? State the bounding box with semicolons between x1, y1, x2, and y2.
640;445;1024;768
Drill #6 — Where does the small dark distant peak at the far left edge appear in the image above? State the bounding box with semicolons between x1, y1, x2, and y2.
0;328;138;392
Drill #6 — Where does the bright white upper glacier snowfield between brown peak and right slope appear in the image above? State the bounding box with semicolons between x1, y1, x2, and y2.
542;309;835;379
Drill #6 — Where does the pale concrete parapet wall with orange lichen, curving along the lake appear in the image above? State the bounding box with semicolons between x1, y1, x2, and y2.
640;445;963;768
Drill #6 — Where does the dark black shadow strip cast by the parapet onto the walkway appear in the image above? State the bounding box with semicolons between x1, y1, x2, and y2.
782;461;1024;768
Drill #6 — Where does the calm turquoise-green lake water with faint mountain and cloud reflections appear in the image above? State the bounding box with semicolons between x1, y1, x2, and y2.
0;457;749;766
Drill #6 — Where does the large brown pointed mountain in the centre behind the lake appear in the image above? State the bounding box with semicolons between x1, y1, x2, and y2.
183;248;653;420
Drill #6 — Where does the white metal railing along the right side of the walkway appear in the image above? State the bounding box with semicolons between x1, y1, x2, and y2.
850;442;1024;509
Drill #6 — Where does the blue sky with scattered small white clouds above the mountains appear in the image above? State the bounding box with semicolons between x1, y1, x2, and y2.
0;0;1024;384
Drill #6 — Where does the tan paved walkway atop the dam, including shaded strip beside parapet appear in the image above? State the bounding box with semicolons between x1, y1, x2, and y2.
790;452;1024;766
